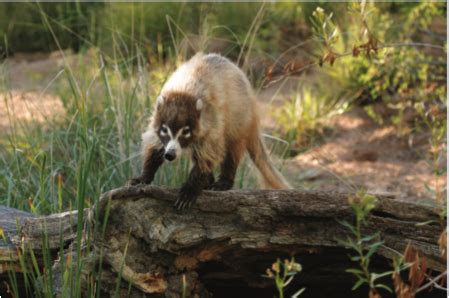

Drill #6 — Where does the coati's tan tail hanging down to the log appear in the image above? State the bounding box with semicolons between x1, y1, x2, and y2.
247;134;292;189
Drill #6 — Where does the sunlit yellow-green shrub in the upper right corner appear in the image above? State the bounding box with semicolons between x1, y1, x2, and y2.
329;3;447;123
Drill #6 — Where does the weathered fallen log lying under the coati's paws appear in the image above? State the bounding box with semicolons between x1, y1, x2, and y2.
0;186;446;297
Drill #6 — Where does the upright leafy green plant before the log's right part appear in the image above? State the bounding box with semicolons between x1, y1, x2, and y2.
341;191;393;297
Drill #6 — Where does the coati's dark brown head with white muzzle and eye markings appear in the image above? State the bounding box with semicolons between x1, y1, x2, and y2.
155;93;203;161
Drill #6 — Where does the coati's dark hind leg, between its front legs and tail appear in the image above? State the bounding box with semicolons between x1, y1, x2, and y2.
210;140;246;190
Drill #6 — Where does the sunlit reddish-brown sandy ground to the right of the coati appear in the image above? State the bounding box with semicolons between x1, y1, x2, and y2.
285;109;446;201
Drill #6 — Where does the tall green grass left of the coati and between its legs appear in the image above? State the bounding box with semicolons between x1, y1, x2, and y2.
0;4;294;297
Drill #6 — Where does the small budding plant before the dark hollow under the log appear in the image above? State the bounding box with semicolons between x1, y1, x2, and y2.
263;258;305;298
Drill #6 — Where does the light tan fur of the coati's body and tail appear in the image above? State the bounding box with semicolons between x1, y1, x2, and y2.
138;53;290;189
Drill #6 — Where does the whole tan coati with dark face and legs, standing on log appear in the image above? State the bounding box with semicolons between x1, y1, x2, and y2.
130;53;290;209
